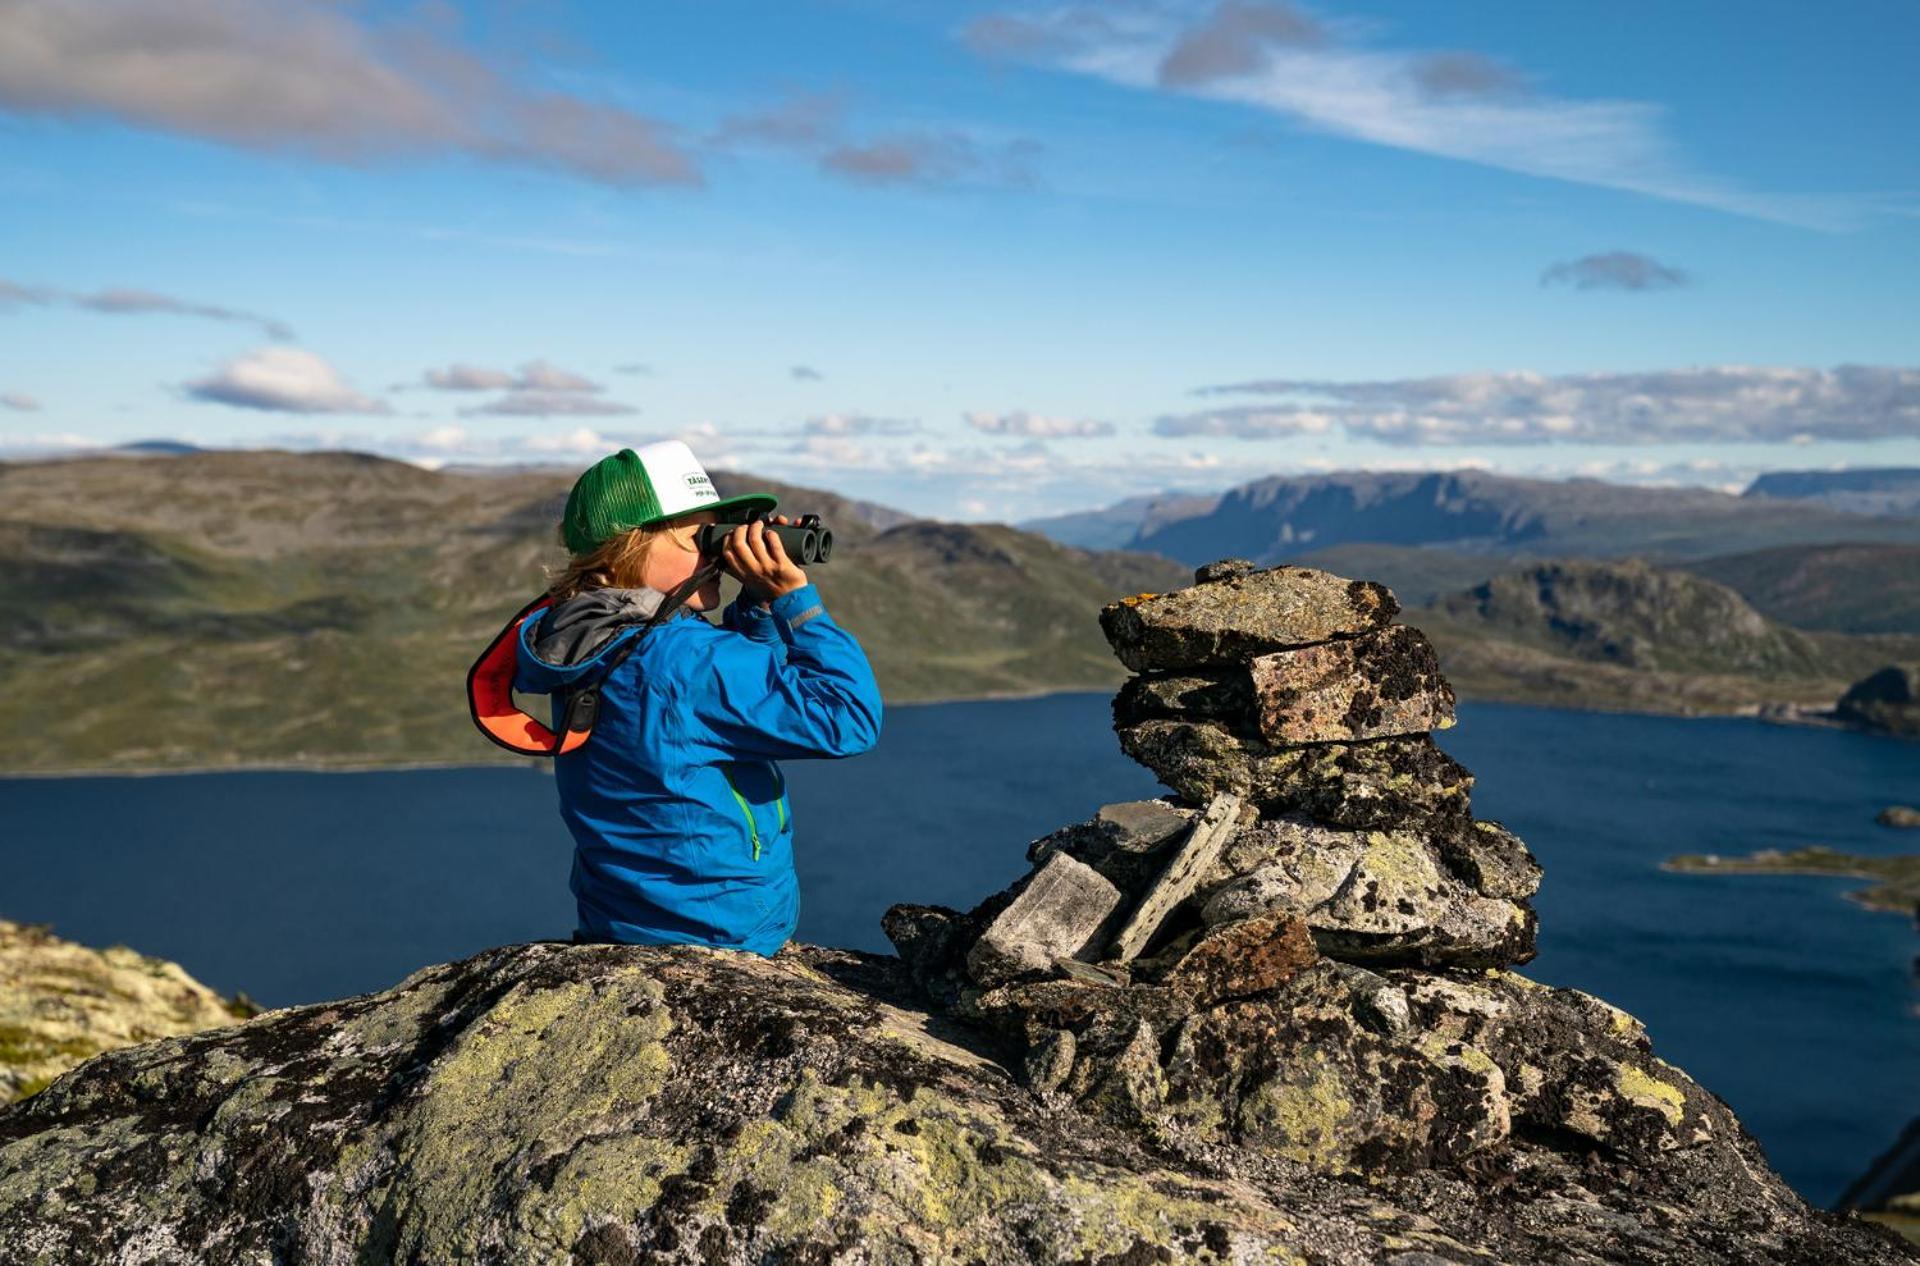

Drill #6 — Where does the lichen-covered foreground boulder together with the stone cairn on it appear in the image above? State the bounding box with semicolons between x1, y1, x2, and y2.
0;559;1920;1266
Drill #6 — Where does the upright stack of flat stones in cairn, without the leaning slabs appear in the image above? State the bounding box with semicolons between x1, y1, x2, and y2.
1100;559;1540;966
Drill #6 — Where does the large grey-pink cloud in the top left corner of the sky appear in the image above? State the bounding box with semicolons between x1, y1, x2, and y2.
0;0;701;184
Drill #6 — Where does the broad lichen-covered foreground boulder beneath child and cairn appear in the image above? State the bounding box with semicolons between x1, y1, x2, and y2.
0;943;1914;1266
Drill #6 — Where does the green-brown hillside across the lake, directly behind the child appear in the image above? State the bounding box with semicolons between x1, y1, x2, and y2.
0;451;1190;772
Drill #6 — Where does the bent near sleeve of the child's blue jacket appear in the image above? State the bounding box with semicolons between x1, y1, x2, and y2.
680;584;881;761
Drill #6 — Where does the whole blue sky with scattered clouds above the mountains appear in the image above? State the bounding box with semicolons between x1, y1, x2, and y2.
0;0;1920;521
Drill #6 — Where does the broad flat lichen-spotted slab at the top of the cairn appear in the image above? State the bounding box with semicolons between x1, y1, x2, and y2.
1100;567;1400;672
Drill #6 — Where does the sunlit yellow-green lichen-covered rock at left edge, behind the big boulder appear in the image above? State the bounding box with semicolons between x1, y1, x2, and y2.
0;918;259;1103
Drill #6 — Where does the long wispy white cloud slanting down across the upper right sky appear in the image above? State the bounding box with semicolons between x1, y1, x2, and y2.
960;0;1874;229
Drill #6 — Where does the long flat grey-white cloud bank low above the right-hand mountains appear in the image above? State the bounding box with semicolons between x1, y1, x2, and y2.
1152;365;1920;446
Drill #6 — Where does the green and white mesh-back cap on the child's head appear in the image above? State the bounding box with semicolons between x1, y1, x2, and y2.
561;440;778;553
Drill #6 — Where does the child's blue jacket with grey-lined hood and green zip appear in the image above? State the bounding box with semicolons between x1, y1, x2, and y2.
513;584;881;955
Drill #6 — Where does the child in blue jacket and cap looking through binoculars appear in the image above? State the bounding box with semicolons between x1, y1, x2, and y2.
513;440;881;955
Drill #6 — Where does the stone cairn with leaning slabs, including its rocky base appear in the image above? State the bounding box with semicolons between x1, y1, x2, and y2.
881;559;1738;1172
